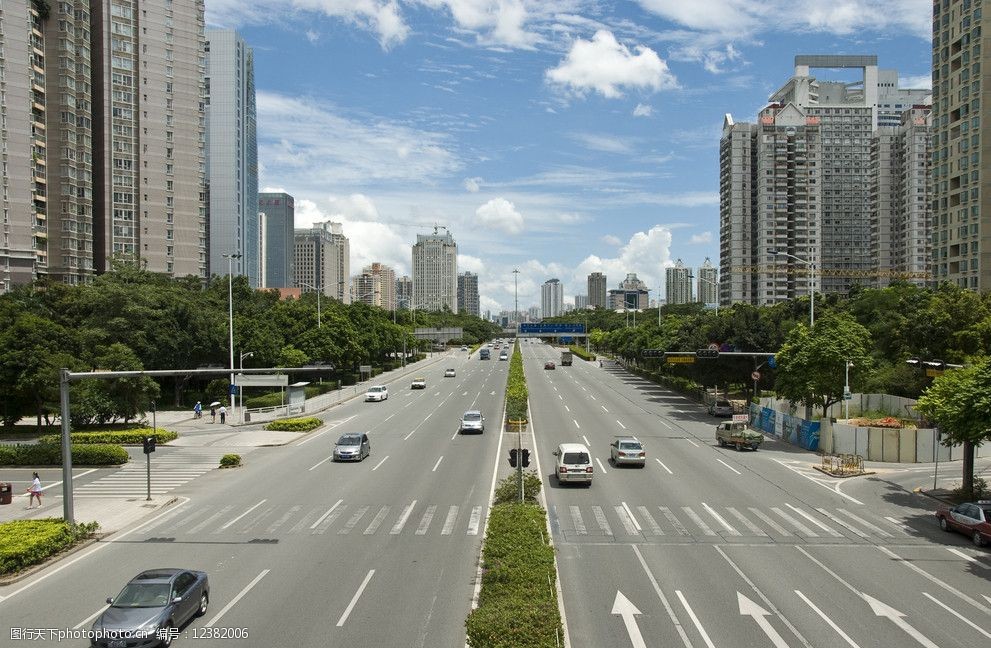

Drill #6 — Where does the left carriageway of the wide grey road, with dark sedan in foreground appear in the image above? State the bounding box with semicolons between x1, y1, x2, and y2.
0;352;508;648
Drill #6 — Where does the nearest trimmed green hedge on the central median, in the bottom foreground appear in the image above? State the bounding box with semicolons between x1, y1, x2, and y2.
465;498;564;648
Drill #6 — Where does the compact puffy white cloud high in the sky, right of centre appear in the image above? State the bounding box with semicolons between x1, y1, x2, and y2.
546;30;678;99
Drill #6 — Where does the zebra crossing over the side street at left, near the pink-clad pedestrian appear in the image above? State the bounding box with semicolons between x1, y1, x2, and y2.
75;449;243;497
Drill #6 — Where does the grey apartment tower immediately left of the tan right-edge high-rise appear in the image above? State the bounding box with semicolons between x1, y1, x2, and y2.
870;106;932;288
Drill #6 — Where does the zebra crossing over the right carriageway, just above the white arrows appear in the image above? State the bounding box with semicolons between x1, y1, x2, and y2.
549;502;922;542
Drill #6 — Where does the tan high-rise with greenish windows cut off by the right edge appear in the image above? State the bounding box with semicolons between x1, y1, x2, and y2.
932;0;991;292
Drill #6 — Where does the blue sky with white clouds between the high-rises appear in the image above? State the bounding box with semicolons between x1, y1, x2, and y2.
206;0;932;311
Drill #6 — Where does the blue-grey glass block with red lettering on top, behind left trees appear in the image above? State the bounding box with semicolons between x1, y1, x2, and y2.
258;192;296;288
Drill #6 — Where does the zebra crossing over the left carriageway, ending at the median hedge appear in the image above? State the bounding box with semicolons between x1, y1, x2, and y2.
140;500;485;538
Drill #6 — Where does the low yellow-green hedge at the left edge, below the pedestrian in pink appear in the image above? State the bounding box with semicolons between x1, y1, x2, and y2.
0;518;99;575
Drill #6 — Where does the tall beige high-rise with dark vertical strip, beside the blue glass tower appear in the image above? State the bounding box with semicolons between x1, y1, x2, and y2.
93;0;209;278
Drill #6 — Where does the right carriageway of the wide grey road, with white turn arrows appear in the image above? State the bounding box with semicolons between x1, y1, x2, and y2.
523;344;991;648
